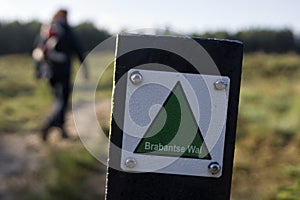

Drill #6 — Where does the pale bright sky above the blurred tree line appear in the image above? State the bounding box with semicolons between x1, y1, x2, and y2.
0;0;300;34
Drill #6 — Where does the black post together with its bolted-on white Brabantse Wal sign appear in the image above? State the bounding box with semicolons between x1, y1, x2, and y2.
106;34;243;200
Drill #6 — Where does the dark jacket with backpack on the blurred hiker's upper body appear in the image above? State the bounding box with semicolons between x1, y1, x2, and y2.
34;20;87;81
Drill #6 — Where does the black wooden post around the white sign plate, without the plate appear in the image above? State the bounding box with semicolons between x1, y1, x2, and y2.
106;35;243;200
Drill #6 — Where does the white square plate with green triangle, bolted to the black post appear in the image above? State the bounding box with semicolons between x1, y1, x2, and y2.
121;69;230;178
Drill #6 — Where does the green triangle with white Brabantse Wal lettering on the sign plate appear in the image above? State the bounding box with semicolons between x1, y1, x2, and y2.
134;82;211;160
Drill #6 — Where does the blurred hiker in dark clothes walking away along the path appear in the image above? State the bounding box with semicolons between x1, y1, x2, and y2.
32;10;88;141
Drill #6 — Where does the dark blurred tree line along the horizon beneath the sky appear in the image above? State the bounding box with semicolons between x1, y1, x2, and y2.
0;21;300;55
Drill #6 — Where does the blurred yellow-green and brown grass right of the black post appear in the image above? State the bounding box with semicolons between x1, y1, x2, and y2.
232;53;300;199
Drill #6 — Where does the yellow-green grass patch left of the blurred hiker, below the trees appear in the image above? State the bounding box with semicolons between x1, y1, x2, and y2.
0;55;51;132
